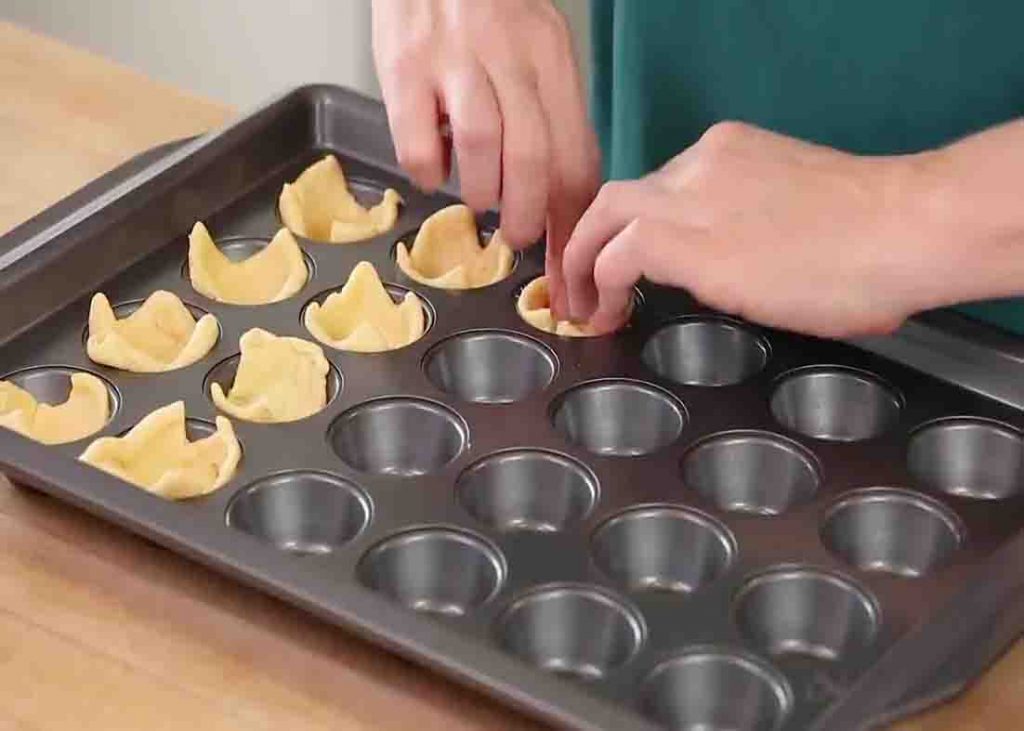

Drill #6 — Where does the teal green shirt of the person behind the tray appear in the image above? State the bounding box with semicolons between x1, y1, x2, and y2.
592;0;1024;334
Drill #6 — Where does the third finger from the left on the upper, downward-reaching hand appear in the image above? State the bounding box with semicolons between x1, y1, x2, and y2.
489;66;549;248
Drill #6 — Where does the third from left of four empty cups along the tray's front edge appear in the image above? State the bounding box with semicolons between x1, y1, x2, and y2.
498;585;644;681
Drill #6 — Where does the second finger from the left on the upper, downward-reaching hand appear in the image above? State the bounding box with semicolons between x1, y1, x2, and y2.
443;61;502;211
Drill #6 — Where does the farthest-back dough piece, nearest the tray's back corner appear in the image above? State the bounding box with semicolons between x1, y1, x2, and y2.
278;155;401;244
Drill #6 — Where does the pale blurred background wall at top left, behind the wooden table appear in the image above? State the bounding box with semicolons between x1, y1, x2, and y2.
0;0;589;110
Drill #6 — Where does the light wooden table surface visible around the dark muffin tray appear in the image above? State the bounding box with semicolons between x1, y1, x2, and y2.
0;23;1024;731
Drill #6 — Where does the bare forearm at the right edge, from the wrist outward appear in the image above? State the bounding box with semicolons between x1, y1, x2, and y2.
894;119;1024;309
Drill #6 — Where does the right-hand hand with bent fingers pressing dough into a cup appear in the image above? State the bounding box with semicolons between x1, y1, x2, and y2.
563;123;962;337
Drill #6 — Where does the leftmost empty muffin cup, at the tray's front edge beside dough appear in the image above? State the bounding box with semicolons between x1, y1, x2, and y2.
226;470;370;554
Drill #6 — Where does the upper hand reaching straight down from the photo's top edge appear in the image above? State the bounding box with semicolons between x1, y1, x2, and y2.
373;0;600;305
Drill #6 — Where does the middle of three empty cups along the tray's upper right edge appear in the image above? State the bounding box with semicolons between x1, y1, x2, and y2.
771;367;901;441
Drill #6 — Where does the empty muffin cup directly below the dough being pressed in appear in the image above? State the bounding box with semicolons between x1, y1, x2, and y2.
553;379;686;457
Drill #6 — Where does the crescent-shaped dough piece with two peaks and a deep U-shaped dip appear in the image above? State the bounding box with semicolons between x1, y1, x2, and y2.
188;221;309;305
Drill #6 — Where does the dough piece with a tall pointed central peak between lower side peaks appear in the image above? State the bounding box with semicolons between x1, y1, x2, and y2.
304;261;426;353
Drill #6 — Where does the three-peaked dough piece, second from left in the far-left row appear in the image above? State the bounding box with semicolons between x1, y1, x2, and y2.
85;290;220;373
